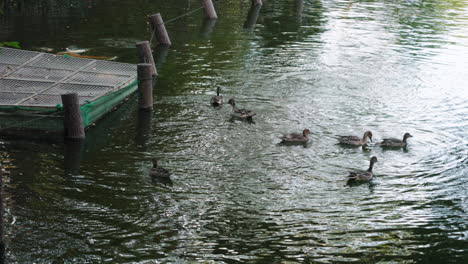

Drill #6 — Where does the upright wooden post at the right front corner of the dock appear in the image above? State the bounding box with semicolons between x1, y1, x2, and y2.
137;63;153;111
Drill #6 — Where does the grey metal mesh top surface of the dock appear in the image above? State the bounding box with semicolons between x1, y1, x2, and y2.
0;47;137;108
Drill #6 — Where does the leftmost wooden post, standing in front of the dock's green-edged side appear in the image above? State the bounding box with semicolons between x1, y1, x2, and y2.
61;93;85;140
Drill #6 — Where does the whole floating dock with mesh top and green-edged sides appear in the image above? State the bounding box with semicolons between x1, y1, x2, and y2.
0;47;138;138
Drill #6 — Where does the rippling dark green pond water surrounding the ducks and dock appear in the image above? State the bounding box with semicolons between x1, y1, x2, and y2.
0;0;468;263
